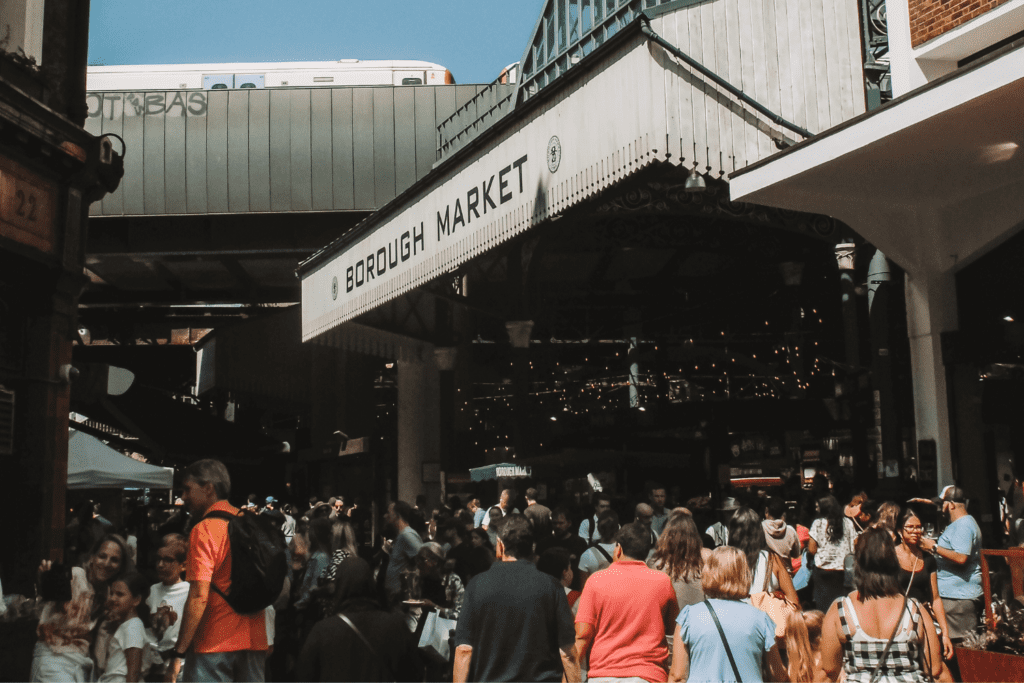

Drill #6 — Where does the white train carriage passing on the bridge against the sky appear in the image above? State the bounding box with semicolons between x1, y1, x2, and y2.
87;59;455;91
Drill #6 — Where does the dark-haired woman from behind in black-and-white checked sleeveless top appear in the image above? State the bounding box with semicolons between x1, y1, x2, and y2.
821;528;942;683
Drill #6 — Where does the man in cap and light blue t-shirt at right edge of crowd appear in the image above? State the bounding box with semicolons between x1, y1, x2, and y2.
915;486;983;643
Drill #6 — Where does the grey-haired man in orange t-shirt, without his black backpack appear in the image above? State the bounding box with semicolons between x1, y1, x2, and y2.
169;460;267;682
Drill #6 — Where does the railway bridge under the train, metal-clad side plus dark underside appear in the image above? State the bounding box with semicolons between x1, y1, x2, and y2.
82;85;513;309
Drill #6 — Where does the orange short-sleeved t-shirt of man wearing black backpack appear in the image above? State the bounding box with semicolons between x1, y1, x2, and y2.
185;501;267;652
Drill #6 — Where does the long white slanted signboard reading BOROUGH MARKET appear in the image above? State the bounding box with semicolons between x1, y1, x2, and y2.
300;32;678;341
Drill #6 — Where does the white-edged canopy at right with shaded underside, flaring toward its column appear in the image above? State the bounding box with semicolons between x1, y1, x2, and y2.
729;39;1024;272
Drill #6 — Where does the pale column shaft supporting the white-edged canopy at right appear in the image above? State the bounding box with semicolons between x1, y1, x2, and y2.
906;268;957;489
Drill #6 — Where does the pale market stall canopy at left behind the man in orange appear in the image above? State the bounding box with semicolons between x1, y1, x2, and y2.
68;429;174;488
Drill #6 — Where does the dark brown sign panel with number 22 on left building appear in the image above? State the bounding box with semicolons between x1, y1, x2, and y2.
0;157;57;255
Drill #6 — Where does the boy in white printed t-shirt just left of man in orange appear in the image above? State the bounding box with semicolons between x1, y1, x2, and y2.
99;573;150;683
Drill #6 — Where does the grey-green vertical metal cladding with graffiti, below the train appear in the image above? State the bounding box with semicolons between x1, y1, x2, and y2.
85;85;486;216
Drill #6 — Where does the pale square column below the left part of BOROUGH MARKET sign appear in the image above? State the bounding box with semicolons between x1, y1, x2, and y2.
397;353;440;505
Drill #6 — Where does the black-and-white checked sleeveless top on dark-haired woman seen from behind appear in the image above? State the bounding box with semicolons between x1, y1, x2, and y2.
838;597;926;683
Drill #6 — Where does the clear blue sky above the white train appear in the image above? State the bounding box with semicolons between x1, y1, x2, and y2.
89;0;544;83
